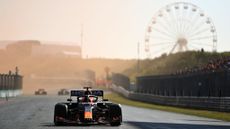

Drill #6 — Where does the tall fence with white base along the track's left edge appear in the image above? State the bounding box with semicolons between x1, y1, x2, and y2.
0;73;23;97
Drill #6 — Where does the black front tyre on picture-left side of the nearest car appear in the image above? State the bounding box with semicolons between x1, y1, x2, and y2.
54;103;68;126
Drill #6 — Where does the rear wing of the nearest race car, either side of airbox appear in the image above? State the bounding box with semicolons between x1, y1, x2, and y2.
70;90;104;97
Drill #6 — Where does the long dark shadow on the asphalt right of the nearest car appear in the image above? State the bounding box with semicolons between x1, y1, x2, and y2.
124;121;230;129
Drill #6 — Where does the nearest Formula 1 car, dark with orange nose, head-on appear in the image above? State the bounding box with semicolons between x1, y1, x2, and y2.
54;87;122;126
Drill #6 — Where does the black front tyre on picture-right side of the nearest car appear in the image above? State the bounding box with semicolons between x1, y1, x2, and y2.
109;104;122;126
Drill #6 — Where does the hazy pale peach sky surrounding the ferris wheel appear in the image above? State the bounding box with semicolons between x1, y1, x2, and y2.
0;0;230;58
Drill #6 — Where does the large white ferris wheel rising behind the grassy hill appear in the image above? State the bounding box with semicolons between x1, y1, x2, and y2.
145;2;217;57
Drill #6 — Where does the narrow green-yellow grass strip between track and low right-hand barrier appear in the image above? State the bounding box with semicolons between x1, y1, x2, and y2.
105;93;230;121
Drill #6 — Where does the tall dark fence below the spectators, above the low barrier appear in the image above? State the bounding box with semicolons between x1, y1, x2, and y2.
137;70;230;97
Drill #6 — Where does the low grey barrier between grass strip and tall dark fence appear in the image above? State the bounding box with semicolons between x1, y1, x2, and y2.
111;84;230;112
